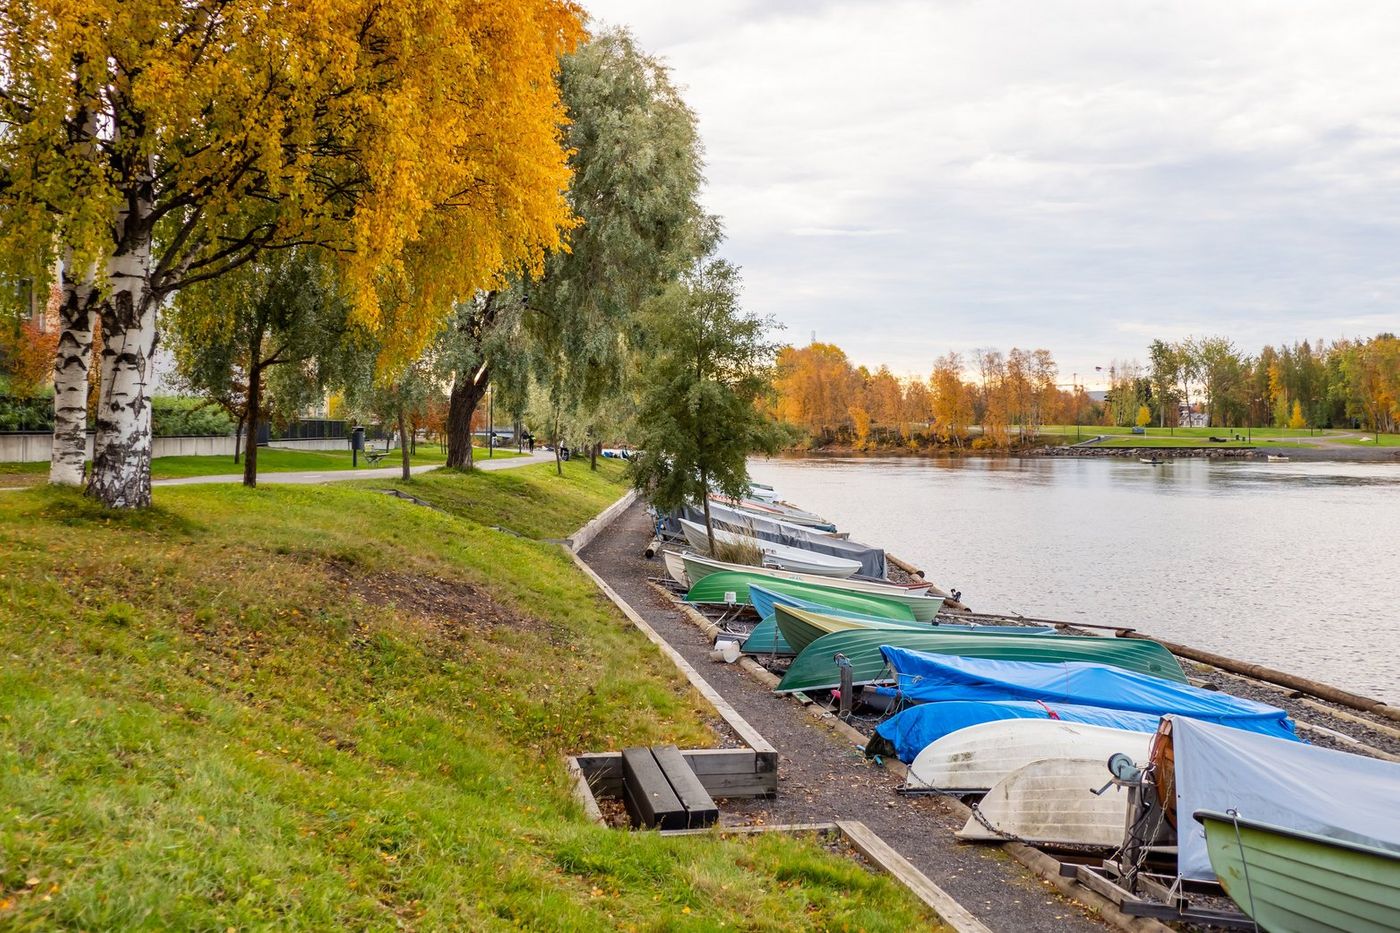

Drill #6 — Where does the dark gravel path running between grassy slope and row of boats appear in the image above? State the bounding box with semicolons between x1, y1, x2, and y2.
581;504;1105;933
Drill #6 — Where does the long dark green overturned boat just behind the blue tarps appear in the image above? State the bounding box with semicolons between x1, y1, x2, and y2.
777;629;1186;693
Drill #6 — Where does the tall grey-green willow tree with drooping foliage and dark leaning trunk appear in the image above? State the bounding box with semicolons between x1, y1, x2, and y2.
444;29;706;467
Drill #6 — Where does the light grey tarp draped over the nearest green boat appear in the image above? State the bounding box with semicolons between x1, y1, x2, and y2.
1170;716;1400;881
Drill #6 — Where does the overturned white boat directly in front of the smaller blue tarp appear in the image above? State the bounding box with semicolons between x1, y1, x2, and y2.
907;719;1152;793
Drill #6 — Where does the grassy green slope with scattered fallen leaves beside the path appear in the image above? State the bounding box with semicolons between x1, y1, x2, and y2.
0;464;940;930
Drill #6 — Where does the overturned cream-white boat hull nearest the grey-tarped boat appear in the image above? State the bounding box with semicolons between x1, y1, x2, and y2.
956;758;1128;849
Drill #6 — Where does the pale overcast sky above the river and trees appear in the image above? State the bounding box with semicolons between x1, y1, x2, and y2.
584;0;1400;382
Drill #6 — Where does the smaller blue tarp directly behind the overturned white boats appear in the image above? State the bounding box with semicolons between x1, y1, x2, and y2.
865;700;1161;762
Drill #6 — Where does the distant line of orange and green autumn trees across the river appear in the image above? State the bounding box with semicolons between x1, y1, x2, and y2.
769;333;1400;450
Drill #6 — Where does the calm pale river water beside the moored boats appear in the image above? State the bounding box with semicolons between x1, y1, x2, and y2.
750;458;1400;703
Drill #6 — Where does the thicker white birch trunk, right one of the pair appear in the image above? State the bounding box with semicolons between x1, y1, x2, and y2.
87;173;160;509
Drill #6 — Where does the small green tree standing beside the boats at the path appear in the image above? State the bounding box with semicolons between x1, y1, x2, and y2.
633;259;778;548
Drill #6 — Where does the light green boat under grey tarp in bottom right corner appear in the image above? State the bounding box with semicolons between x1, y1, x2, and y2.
1194;806;1400;933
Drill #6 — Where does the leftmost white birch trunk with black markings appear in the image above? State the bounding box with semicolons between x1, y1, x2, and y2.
49;249;97;486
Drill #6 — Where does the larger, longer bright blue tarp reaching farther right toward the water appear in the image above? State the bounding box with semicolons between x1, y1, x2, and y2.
881;639;1298;741
